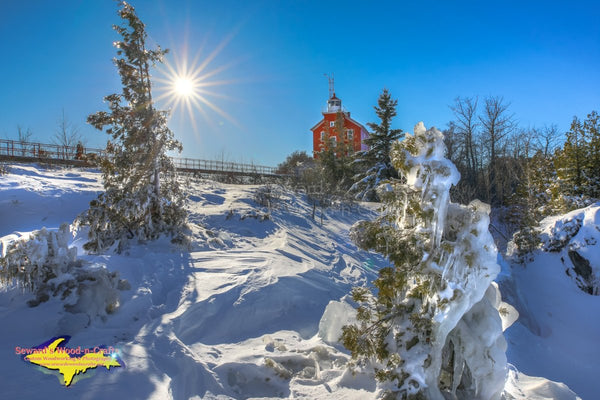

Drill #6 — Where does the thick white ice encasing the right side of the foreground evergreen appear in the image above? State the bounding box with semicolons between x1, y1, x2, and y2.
406;123;507;400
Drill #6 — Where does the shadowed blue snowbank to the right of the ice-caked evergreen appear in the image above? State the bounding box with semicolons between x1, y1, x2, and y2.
498;203;600;399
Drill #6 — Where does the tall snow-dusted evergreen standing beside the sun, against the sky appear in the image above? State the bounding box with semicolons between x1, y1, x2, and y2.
80;2;186;252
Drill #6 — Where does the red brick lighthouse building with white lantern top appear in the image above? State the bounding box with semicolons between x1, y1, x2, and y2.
310;77;369;158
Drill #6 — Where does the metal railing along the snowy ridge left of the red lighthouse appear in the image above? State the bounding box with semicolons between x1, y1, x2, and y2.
0;139;279;176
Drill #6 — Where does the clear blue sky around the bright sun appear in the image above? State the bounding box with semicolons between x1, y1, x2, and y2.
0;0;600;165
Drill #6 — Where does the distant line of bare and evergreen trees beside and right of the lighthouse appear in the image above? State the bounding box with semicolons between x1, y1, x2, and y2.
278;89;600;238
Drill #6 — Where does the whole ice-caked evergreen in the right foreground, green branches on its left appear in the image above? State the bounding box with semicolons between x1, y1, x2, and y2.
342;123;506;400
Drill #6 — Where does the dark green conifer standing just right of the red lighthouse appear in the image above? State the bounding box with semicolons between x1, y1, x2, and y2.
350;89;402;201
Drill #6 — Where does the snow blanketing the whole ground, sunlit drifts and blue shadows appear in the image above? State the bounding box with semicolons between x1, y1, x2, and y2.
0;165;600;399
